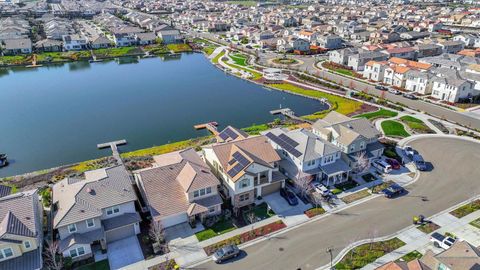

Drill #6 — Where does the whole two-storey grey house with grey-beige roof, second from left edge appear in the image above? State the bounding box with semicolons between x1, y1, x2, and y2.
52;165;141;261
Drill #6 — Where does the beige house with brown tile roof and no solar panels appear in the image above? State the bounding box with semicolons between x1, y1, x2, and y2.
134;148;223;228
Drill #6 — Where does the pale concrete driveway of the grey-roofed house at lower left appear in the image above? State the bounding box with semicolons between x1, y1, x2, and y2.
107;236;143;270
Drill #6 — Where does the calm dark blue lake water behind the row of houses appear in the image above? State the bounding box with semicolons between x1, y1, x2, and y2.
0;54;324;176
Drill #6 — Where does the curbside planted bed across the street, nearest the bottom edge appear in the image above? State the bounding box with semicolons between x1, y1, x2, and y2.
335;238;405;269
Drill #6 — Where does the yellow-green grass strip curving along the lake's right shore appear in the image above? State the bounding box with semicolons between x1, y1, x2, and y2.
269;83;362;118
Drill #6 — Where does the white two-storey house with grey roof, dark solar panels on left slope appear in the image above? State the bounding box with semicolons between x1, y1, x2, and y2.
262;128;350;185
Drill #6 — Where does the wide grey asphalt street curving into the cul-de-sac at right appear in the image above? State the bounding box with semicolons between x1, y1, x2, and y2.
195;138;480;270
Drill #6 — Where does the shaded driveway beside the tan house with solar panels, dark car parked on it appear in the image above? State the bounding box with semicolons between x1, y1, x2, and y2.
263;192;312;226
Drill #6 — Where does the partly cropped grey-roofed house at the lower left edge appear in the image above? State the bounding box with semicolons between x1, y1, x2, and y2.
0;190;43;270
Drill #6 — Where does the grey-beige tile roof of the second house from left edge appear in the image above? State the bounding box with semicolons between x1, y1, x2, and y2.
52;165;137;228
